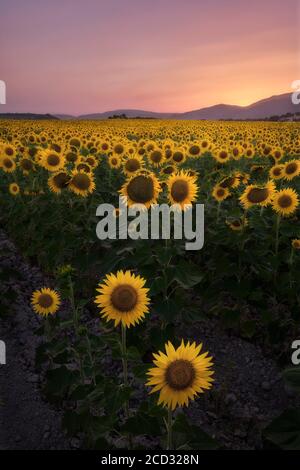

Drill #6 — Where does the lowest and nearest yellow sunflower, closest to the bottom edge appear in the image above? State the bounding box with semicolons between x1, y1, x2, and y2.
147;340;214;410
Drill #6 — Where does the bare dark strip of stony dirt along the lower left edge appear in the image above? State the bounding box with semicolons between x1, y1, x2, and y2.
0;230;69;449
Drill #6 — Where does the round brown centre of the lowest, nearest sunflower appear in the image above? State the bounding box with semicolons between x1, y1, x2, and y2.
165;359;196;390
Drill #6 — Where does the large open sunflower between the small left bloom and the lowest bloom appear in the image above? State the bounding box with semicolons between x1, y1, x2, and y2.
95;271;150;328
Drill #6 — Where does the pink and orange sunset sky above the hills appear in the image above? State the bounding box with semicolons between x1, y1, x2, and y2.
0;0;300;115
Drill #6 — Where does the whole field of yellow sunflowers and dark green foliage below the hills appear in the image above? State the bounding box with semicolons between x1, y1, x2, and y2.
0;119;300;449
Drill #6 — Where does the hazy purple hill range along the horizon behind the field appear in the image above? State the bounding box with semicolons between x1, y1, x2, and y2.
0;93;300;120
